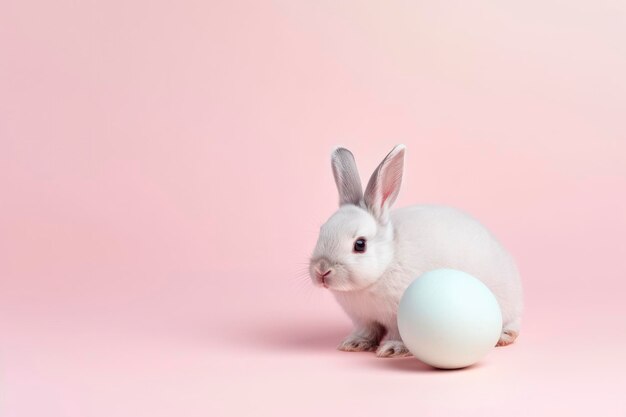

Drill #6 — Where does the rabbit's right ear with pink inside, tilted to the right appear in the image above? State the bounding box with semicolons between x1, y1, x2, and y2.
365;145;405;223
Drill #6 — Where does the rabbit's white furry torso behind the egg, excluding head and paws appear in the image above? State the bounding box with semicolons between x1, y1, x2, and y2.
333;205;522;352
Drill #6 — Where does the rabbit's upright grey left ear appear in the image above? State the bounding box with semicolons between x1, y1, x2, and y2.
331;148;363;206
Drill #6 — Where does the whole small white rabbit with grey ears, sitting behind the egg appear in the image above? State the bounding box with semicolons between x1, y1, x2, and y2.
309;145;522;357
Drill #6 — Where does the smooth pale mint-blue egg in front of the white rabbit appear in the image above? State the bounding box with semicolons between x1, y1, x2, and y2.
398;269;502;369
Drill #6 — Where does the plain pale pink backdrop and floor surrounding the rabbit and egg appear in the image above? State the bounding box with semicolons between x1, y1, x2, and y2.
0;0;626;417
